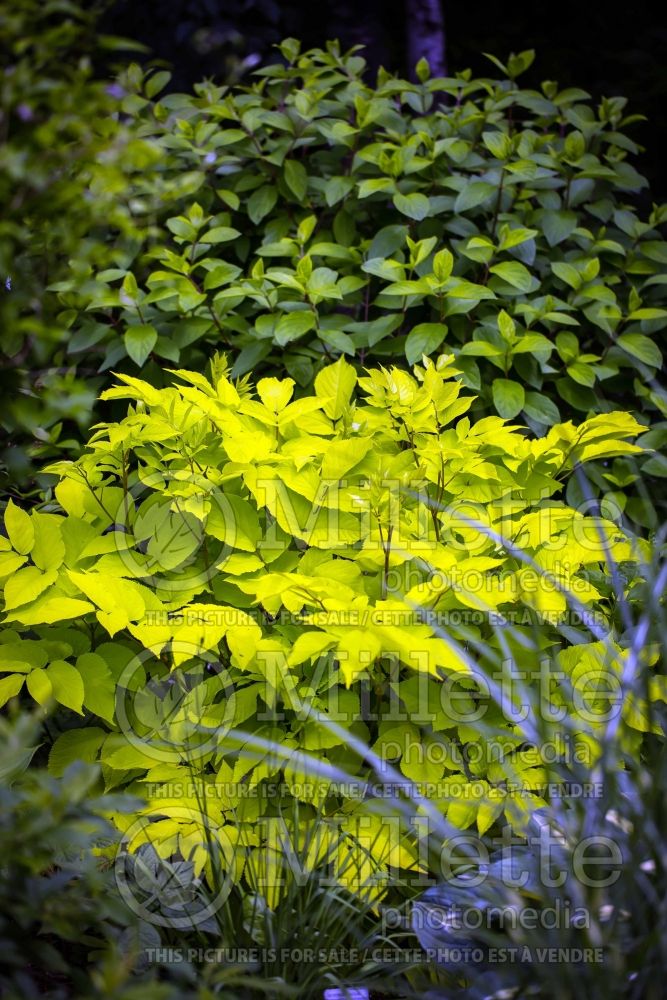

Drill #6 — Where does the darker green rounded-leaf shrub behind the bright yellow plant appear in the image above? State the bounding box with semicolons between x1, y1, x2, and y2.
6;23;667;524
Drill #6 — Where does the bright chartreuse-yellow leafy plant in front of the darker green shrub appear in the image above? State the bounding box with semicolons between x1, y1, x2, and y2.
0;355;665;905
